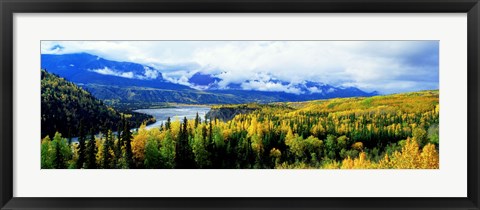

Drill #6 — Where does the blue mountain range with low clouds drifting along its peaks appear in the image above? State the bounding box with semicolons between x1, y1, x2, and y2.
41;53;378;104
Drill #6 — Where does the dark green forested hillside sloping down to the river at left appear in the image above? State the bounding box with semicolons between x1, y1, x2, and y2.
41;70;154;138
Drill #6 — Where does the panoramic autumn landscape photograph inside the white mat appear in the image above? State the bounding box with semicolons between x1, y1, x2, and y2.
39;40;440;169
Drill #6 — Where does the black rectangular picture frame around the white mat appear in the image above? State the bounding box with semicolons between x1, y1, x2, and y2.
0;0;480;209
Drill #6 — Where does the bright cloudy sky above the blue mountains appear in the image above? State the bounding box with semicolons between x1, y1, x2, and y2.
41;41;439;94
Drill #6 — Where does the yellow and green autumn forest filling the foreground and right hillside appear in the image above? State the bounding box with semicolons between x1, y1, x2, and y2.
41;89;439;169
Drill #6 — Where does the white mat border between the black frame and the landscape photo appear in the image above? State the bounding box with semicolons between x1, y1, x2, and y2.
13;13;467;197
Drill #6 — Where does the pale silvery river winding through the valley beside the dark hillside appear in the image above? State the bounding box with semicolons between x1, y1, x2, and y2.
134;105;210;129
